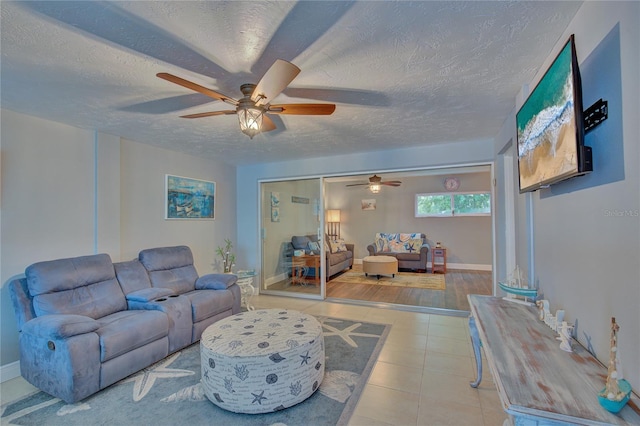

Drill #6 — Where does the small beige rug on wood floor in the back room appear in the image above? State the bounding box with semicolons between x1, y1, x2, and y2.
332;267;446;290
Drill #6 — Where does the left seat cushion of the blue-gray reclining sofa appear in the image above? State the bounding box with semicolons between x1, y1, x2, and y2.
96;310;169;362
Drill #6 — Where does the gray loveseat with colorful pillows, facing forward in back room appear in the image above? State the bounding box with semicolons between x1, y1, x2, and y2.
367;233;431;272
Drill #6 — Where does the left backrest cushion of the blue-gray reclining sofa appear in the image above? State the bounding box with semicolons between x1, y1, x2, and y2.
25;254;127;319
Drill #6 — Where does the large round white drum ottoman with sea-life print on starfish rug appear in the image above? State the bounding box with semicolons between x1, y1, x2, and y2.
200;309;324;414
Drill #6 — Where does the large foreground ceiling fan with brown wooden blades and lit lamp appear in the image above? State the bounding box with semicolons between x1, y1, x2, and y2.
156;59;336;139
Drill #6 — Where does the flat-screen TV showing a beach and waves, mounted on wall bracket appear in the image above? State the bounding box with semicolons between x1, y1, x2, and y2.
516;35;592;193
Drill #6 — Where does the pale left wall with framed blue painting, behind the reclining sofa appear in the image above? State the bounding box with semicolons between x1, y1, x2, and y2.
0;110;238;380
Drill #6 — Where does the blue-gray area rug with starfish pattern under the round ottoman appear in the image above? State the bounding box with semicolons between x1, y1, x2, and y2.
0;316;391;426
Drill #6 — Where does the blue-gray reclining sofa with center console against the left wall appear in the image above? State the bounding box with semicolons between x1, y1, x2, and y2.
9;246;240;403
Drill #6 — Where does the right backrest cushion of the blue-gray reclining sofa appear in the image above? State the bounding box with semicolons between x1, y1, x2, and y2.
138;246;198;294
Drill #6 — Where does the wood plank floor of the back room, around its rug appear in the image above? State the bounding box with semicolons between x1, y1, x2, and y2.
269;265;493;311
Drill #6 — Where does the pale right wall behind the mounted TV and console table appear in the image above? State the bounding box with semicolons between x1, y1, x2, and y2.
496;2;640;389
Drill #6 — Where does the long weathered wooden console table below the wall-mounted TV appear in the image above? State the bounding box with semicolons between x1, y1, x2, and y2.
467;295;640;425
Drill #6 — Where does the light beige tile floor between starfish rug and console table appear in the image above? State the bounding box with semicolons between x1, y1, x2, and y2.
0;295;506;426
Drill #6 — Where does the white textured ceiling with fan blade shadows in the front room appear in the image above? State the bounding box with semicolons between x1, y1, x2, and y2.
0;1;581;164
